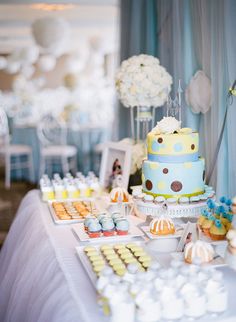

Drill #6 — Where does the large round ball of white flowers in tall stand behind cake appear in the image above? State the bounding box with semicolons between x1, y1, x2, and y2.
115;54;172;107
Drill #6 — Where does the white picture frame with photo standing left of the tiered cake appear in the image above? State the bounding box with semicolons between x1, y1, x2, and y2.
99;142;132;189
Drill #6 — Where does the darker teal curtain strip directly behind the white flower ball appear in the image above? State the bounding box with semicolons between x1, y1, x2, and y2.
118;0;158;139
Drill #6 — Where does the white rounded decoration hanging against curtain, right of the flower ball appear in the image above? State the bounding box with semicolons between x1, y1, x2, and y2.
185;70;211;114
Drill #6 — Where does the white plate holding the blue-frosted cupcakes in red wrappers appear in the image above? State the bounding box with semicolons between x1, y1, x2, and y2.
72;220;144;243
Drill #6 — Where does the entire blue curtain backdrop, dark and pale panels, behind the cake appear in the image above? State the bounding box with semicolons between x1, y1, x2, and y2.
119;0;236;197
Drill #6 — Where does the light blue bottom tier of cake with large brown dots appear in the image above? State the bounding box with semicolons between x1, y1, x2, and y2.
142;158;205;198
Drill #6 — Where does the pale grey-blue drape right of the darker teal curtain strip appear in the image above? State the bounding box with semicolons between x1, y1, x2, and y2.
158;0;236;196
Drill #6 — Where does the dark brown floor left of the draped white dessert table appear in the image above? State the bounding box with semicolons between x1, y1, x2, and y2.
0;170;36;246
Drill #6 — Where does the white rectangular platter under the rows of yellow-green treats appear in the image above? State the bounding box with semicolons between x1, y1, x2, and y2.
75;241;153;287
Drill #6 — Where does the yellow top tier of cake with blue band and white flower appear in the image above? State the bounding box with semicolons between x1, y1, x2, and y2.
147;117;199;162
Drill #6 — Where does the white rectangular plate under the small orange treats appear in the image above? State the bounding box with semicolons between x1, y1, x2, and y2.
48;198;105;225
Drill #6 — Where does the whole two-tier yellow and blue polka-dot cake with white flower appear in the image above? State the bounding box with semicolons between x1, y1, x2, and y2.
142;117;205;198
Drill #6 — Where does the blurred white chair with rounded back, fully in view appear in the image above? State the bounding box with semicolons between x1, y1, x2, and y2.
37;115;77;177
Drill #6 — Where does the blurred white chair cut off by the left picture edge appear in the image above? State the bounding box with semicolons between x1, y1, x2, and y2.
0;107;34;189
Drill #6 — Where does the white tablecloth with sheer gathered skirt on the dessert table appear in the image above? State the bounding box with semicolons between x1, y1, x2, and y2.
0;190;236;322
